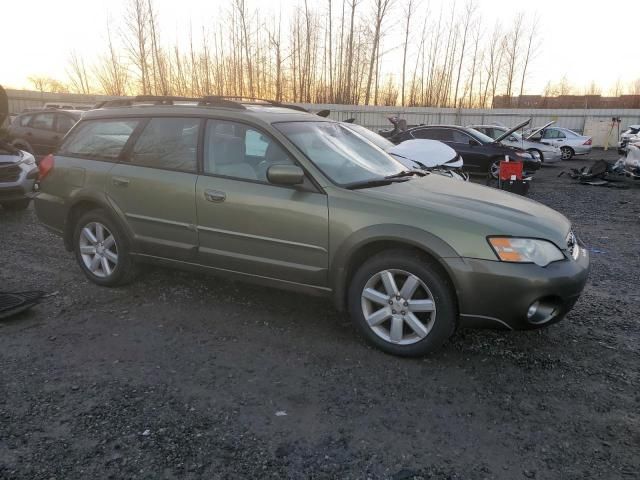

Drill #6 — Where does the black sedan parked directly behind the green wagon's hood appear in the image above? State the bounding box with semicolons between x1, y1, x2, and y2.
390;125;540;178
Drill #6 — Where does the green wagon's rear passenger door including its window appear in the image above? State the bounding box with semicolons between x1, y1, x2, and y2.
106;117;201;261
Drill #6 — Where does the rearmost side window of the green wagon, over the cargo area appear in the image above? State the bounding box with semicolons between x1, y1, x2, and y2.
59;119;140;160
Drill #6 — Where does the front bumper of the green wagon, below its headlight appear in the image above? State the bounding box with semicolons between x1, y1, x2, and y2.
447;246;589;330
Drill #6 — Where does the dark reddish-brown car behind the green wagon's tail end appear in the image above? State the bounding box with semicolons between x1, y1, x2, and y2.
8;109;83;155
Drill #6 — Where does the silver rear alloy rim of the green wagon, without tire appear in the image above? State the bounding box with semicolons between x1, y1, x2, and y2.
79;222;118;278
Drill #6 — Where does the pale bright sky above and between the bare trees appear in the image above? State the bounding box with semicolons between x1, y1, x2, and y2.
0;0;640;93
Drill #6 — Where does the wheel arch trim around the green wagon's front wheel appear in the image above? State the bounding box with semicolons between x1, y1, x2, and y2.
330;225;460;311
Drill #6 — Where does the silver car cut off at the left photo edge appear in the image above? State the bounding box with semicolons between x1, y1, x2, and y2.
0;141;38;210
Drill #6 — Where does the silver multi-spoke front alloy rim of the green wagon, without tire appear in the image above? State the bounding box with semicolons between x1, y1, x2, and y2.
361;270;436;345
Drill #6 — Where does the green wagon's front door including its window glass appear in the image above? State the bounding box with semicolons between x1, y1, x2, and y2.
196;120;329;287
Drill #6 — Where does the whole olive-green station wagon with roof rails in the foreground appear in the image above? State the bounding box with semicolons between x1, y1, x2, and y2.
35;97;589;356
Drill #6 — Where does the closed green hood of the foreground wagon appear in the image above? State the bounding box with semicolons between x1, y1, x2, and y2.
362;175;571;250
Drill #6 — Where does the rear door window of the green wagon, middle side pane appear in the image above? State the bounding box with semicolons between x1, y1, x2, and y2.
129;118;200;173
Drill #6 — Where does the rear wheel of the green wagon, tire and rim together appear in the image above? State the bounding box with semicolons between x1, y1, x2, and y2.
73;209;137;287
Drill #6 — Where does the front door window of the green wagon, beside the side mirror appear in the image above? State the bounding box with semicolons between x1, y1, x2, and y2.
204;120;295;182
